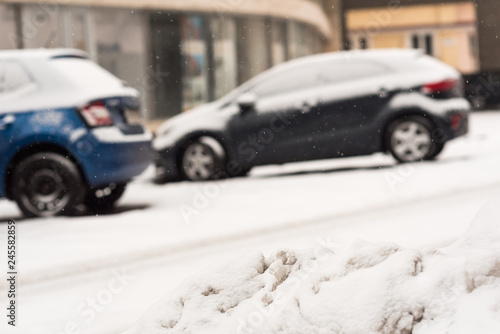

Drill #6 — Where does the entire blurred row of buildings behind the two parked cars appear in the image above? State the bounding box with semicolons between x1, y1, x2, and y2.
0;0;500;130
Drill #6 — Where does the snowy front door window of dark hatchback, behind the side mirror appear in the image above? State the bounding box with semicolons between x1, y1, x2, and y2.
250;66;322;98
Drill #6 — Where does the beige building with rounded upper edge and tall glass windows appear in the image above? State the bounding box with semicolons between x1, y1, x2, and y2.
0;0;332;120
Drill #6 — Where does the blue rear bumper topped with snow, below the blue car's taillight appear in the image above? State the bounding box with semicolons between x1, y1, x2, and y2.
76;128;153;187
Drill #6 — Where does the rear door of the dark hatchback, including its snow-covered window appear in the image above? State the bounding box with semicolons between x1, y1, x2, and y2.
315;58;393;158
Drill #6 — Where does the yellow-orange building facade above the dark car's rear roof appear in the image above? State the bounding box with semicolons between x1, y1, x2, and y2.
346;1;479;74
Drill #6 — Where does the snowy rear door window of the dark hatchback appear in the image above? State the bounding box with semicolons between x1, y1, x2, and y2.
320;60;387;84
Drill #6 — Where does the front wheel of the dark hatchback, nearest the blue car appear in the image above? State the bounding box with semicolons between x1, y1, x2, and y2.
181;137;226;181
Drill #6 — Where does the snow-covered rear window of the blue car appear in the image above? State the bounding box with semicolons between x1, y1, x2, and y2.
51;57;123;89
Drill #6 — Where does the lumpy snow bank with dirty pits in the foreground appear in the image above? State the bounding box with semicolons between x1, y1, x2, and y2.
127;199;500;334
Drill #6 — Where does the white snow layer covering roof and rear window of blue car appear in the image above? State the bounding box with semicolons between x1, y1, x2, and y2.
0;49;138;114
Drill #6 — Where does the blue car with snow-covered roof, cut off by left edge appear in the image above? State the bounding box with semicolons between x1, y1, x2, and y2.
0;49;152;217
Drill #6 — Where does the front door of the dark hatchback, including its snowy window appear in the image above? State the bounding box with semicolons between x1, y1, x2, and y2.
228;65;318;166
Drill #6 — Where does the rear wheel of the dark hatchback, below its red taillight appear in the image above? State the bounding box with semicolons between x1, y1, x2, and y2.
386;115;444;163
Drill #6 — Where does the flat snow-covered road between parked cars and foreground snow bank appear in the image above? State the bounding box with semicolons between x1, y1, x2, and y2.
0;112;500;334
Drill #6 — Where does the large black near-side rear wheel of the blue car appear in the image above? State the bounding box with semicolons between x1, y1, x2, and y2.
10;152;86;217
